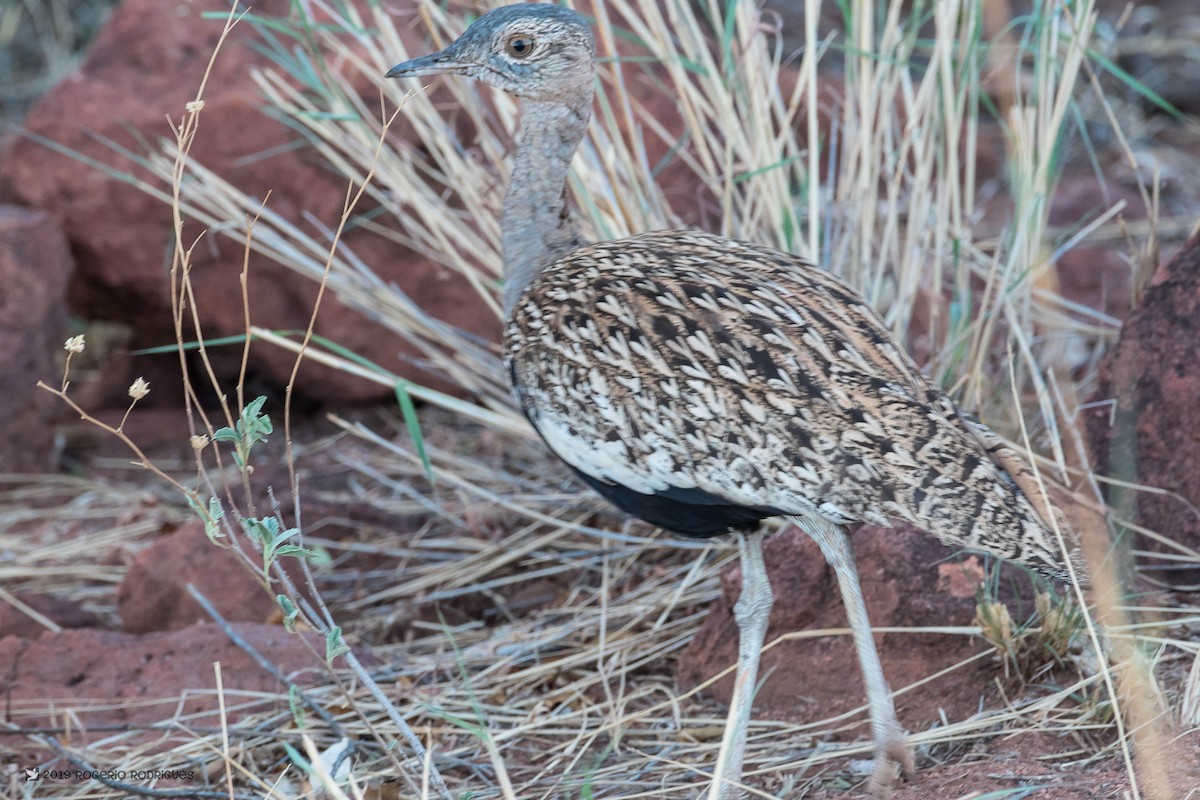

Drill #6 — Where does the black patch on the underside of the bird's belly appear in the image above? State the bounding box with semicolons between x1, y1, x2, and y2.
571;467;784;537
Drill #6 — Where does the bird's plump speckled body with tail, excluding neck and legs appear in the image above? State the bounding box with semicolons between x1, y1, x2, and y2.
505;231;1080;578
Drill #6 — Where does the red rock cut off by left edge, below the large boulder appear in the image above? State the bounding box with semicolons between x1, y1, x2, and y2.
0;206;72;473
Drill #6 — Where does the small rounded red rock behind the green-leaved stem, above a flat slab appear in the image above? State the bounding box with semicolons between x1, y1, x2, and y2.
116;522;278;633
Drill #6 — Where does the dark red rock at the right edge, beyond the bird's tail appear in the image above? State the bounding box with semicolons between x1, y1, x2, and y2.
1086;236;1200;583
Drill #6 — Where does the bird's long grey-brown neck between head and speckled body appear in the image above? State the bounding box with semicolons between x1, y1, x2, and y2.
502;91;592;314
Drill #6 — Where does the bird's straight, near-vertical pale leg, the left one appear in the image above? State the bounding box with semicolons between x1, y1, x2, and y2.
708;530;775;800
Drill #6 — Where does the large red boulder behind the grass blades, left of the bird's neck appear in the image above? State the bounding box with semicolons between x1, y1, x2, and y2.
0;0;499;401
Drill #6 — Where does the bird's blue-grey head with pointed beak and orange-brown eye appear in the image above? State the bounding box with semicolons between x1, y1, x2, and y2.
388;2;595;102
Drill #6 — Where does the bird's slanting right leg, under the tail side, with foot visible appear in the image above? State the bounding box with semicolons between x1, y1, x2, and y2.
804;519;913;798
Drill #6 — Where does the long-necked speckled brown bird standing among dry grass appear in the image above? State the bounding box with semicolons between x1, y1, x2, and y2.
386;2;1078;800
